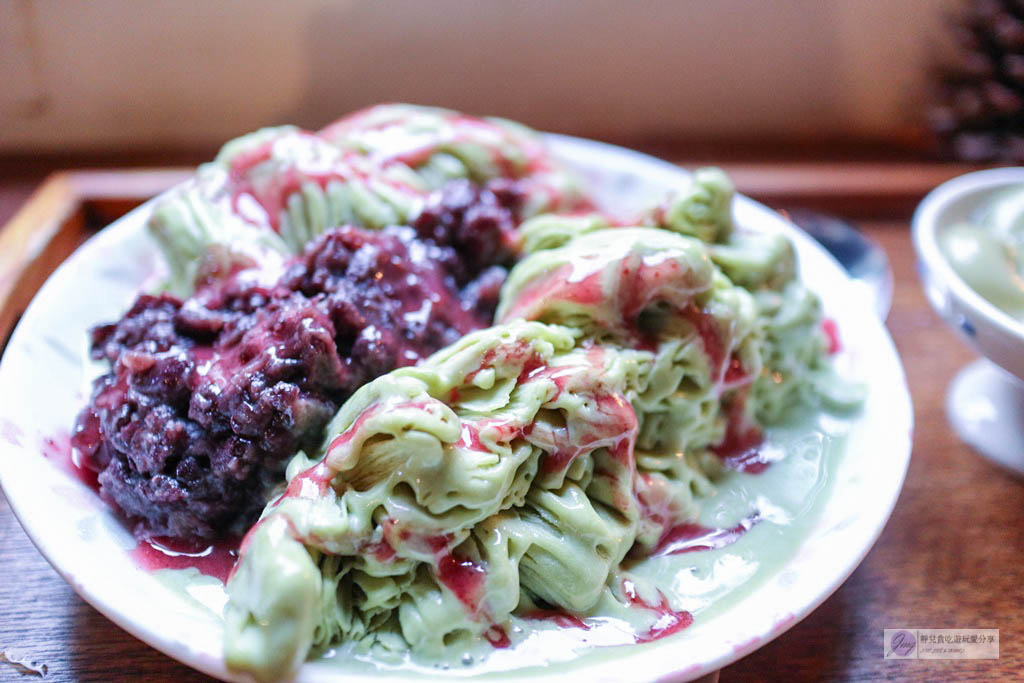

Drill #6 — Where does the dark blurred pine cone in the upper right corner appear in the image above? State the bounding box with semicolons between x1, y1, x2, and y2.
929;0;1024;163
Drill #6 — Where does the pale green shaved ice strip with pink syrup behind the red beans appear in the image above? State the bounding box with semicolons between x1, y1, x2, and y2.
147;104;586;296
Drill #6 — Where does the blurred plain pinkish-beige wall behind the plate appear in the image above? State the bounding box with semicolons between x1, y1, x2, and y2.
0;0;956;153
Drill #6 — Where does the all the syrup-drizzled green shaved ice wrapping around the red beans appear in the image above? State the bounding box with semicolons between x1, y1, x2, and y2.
174;116;863;680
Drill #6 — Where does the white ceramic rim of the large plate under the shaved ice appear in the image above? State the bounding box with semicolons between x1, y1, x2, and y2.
0;136;912;681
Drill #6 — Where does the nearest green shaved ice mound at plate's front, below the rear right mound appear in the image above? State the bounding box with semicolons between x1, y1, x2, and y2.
226;322;640;678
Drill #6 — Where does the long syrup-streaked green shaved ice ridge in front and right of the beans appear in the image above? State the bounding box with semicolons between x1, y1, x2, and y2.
222;210;847;675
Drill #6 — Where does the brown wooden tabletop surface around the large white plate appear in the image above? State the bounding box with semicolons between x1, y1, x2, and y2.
0;164;1024;683
